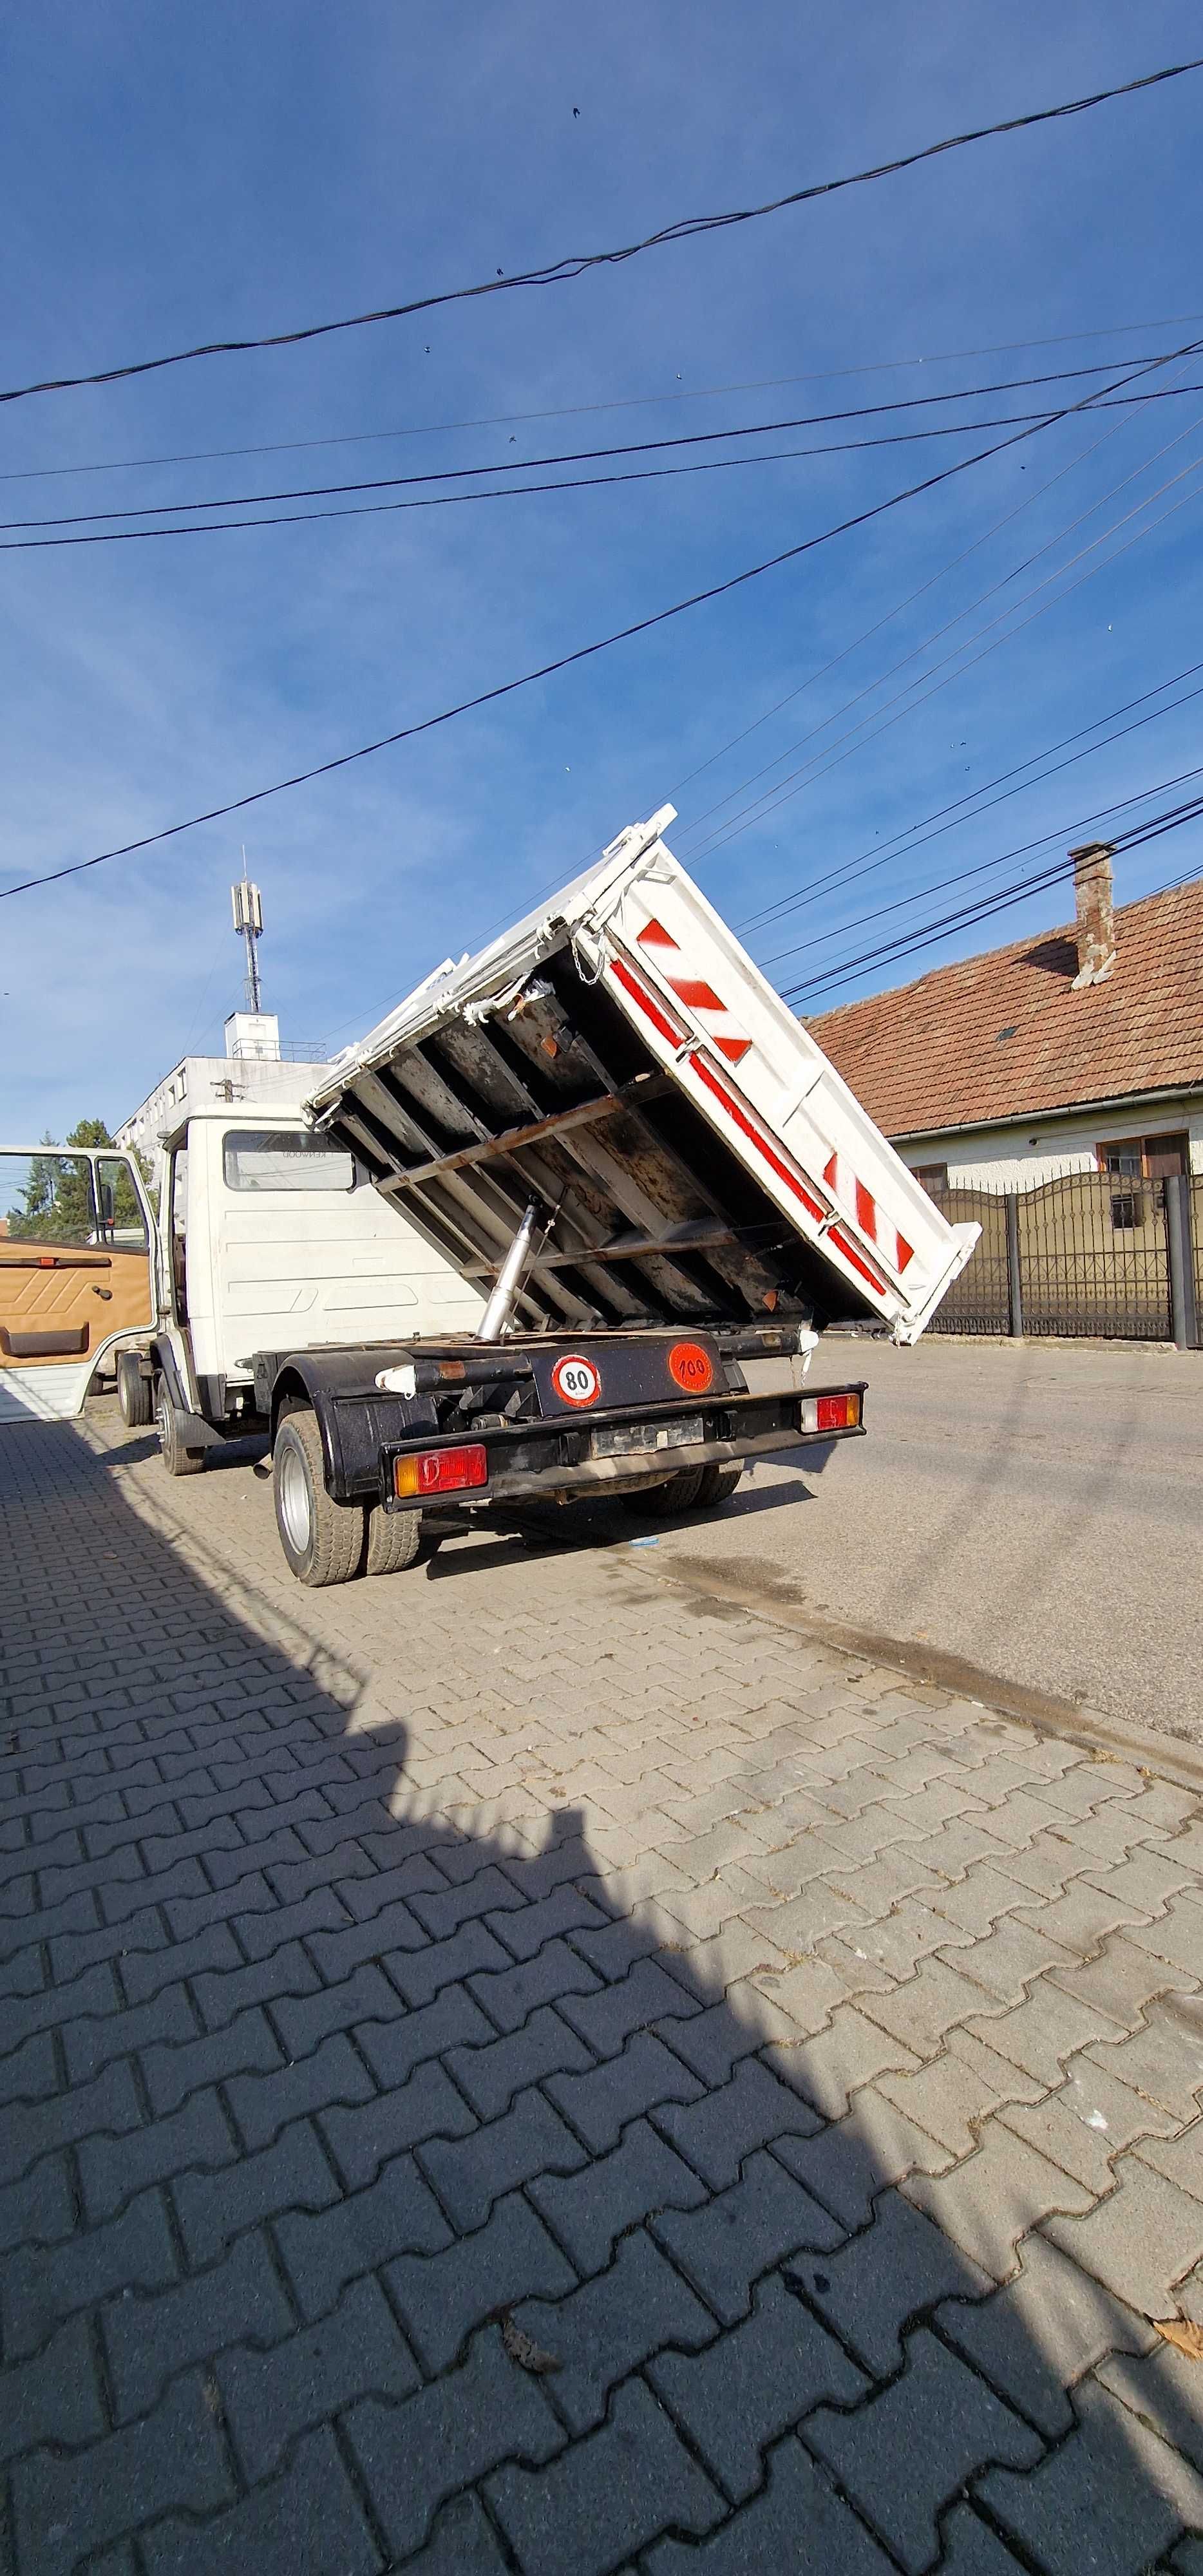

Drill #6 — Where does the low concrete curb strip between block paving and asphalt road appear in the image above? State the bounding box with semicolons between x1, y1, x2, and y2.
631;1558;1203;1798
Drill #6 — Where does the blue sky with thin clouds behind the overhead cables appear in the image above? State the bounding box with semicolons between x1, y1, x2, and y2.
0;0;1203;1136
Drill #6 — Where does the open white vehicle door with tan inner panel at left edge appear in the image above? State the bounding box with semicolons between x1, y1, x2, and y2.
0;1144;155;1422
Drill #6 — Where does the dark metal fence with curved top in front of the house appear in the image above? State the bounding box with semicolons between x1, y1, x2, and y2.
930;1172;1203;1350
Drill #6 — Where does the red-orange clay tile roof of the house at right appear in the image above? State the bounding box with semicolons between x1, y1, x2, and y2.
806;878;1203;1136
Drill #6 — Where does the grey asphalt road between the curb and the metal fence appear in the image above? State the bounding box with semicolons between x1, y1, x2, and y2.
647;1337;1203;1741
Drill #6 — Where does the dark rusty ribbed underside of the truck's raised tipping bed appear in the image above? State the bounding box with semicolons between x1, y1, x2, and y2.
322;948;873;1332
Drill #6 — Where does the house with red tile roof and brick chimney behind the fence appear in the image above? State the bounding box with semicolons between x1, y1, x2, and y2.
806;842;1203;1190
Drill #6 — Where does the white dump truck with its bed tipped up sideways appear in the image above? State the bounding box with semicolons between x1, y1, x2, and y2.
0;806;976;1584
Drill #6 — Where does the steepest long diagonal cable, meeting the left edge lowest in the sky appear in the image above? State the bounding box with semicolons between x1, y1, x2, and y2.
0;350;1190;902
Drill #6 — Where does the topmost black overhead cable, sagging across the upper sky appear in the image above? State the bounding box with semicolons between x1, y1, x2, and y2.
0;54;1203;402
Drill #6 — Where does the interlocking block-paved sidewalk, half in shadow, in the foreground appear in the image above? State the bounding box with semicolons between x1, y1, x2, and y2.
0;1430;1203;2576
